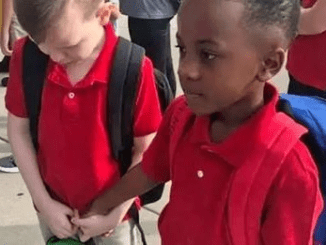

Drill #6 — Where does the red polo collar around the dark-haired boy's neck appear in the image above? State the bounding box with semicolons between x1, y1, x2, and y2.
190;83;279;167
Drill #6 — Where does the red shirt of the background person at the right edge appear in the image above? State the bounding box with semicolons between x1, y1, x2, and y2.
286;0;326;91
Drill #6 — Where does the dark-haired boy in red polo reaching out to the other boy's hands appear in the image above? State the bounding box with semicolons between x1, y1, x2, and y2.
72;0;323;245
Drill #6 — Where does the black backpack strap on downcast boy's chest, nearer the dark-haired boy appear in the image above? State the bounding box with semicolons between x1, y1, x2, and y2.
107;37;145;175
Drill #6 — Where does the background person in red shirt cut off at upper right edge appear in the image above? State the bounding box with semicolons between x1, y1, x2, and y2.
287;0;326;98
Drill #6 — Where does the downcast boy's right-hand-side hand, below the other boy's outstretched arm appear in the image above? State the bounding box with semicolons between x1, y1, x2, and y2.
71;208;125;242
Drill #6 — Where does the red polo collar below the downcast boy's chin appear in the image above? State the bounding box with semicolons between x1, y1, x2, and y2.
48;24;118;88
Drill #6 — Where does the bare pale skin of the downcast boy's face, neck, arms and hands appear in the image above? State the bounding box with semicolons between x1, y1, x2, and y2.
7;0;154;241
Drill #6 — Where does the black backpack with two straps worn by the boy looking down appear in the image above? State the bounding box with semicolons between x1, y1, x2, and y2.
23;37;174;244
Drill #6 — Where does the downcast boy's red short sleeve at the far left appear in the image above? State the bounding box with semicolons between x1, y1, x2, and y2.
5;38;28;118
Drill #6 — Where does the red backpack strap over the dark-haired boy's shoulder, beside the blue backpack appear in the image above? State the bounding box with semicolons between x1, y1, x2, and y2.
227;113;306;245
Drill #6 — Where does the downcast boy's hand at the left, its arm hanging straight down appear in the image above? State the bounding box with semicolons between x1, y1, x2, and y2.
38;200;78;239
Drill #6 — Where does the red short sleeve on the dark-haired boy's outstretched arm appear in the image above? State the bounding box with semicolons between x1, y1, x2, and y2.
141;98;184;182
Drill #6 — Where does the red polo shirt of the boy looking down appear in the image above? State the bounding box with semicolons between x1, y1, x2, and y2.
6;25;161;211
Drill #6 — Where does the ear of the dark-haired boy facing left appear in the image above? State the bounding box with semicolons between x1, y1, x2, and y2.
257;47;285;82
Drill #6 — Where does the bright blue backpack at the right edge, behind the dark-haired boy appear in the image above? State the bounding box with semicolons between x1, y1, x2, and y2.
279;94;326;244
